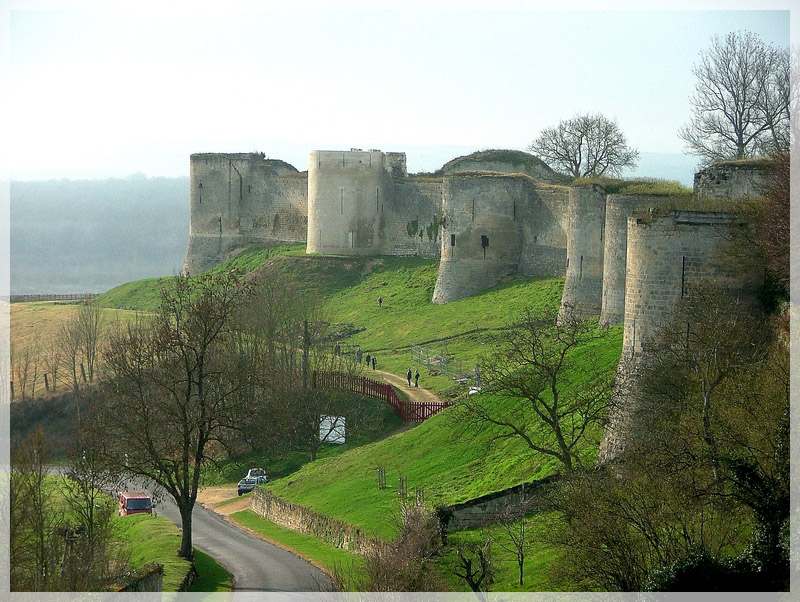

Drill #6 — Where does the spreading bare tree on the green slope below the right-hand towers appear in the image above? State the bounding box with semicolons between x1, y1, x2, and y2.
453;309;613;470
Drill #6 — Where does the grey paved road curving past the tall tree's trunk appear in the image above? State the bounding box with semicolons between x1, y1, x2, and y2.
156;492;328;592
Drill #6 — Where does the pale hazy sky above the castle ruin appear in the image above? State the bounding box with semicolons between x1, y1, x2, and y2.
1;2;789;180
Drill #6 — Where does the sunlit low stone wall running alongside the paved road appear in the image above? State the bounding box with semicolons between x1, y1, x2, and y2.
250;489;378;554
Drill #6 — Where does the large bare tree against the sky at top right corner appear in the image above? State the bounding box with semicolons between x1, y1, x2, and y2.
679;31;790;163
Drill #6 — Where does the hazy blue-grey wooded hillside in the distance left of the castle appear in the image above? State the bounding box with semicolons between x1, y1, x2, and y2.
10;175;189;295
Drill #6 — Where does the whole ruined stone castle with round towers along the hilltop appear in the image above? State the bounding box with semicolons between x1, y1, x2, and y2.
184;149;764;461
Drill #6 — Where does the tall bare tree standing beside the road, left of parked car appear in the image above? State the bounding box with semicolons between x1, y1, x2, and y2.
98;273;257;558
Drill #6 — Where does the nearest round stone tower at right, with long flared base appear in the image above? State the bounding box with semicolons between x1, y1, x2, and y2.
599;211;763;463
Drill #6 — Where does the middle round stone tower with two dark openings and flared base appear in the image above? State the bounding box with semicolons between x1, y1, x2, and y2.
433;173;528;303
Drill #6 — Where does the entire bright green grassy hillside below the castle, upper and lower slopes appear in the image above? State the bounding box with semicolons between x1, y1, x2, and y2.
92;246;622;536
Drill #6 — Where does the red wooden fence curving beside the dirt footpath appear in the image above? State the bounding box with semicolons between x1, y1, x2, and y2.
311;370;453;422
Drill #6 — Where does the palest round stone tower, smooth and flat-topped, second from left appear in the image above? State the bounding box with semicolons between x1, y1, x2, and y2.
306;150;392;255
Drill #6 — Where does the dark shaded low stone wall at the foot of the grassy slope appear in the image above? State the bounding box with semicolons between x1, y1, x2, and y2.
436;474;559;534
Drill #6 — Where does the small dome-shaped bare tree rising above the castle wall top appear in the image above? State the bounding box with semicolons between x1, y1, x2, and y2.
528;113;639;178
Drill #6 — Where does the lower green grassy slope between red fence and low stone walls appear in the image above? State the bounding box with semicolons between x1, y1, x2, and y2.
267;318;622;536
